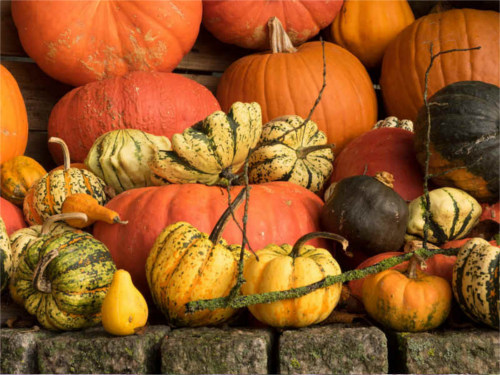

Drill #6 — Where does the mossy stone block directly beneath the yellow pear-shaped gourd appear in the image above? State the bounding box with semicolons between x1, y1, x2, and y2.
38;326;170;374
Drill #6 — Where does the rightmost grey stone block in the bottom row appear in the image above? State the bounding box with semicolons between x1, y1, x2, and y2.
395;328;500;374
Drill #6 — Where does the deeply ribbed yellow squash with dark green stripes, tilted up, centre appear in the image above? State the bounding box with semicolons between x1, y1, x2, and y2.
150;102;262;185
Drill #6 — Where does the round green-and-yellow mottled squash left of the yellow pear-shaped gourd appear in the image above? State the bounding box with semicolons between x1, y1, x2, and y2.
12;232;116;330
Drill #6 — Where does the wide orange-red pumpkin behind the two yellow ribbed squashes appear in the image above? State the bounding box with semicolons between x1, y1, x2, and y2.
93;182;328;296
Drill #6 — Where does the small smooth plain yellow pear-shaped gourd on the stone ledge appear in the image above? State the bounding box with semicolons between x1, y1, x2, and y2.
101;270;148;336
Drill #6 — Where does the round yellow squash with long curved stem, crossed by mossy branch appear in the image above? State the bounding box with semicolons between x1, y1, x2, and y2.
241;232;348;327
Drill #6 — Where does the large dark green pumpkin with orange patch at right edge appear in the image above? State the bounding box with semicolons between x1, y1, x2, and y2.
415;81;500;202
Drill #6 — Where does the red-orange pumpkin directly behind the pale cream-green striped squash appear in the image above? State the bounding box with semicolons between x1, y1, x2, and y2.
48;72;220;164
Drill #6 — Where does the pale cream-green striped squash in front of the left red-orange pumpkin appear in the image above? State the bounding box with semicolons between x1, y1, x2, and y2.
85;129;172;193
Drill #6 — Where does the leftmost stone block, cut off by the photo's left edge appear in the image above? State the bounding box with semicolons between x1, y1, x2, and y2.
0;328;53;374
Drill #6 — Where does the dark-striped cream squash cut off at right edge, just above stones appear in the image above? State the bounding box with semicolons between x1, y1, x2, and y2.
453;238;500;329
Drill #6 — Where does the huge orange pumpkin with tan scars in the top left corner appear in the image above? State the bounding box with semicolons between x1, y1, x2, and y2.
12;0;202;86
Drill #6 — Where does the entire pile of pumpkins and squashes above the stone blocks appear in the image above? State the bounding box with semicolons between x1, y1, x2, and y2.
0;0;500;334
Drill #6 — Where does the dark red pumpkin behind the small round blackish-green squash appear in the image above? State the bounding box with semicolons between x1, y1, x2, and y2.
325;128;424;201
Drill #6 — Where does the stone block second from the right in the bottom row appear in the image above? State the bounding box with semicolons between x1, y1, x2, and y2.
279;324;388;374
